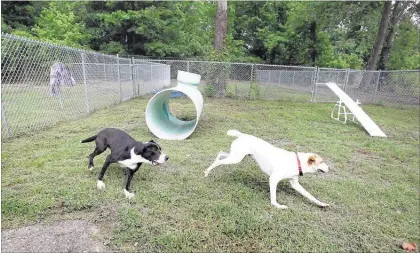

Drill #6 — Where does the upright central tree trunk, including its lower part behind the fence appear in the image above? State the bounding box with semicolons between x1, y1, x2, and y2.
211;0;227;97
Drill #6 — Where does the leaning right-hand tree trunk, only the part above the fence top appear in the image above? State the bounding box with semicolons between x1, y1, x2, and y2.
366;1;392;70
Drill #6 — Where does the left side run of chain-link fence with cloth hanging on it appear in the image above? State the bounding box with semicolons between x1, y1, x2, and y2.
1;34;170;139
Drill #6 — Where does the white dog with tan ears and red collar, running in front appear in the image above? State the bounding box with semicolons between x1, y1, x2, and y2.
204;130;329;209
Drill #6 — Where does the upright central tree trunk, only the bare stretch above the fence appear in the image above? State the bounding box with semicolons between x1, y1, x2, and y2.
214;0;227;51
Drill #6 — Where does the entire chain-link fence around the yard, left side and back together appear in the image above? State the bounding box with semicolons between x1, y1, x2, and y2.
1;34;420;138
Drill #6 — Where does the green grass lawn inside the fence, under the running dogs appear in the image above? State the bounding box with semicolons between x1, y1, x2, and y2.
1;98;420;252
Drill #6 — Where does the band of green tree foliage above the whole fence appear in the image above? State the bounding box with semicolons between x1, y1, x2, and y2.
1;1;420;69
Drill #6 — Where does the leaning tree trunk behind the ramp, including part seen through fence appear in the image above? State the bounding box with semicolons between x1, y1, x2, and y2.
359;1;392;90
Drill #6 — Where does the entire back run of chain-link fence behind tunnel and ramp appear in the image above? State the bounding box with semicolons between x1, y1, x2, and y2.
136;56;420;107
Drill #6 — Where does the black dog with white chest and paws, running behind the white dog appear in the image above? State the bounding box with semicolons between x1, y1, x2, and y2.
81;128;169;198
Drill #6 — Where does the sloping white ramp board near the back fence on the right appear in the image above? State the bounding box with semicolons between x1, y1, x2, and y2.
326;83;386;137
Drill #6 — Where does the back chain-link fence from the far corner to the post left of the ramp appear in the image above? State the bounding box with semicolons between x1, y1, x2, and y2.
135;58;316;101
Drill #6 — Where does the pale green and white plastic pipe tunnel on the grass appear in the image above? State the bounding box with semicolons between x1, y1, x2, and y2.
145;71;203;140
